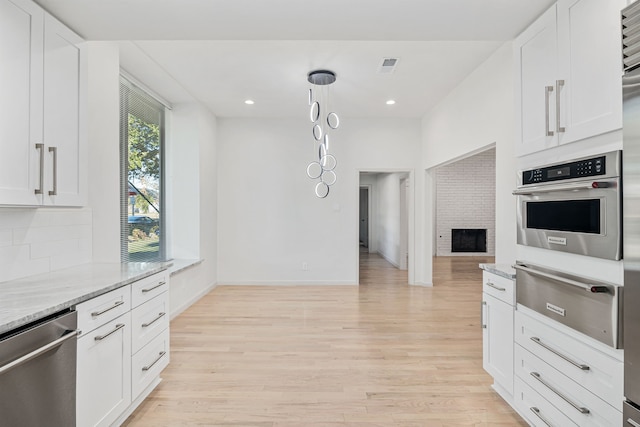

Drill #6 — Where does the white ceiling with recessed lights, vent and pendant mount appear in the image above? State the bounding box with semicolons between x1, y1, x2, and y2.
38;0;553;118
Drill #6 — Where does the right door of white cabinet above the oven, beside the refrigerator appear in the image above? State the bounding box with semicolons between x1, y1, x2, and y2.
557;0;626;144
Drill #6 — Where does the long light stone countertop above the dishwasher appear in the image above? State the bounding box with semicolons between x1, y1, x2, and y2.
0;262;169;334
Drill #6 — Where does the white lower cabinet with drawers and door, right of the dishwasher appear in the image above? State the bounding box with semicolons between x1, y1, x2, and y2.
76;272;169;427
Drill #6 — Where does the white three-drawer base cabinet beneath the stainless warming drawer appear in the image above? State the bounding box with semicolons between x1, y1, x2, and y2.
514;306;623;427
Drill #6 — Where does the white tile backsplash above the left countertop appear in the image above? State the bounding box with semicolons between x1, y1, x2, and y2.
0;208;92;282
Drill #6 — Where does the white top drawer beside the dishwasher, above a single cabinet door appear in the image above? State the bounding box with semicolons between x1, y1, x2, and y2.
76;286;131;335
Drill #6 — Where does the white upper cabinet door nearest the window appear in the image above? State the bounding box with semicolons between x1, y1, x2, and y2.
44;15;87;206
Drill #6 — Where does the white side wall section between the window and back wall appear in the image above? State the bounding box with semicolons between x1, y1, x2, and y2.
167;103;218;317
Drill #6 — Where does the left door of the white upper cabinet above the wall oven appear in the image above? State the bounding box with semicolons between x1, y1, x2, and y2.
514;5;556;155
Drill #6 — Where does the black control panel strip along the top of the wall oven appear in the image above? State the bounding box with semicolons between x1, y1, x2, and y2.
522;156;606;185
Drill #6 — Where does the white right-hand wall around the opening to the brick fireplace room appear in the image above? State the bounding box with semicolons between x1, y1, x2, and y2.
422;43;516;269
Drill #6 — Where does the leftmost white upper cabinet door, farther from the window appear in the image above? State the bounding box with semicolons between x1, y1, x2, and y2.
0;0;44;205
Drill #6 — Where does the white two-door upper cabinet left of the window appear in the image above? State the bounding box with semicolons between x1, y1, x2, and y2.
0;0;86;206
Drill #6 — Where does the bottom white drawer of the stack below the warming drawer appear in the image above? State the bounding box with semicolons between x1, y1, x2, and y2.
513;376;577;427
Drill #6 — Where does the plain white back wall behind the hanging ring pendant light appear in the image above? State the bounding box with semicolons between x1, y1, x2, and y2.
218;118;420;284
